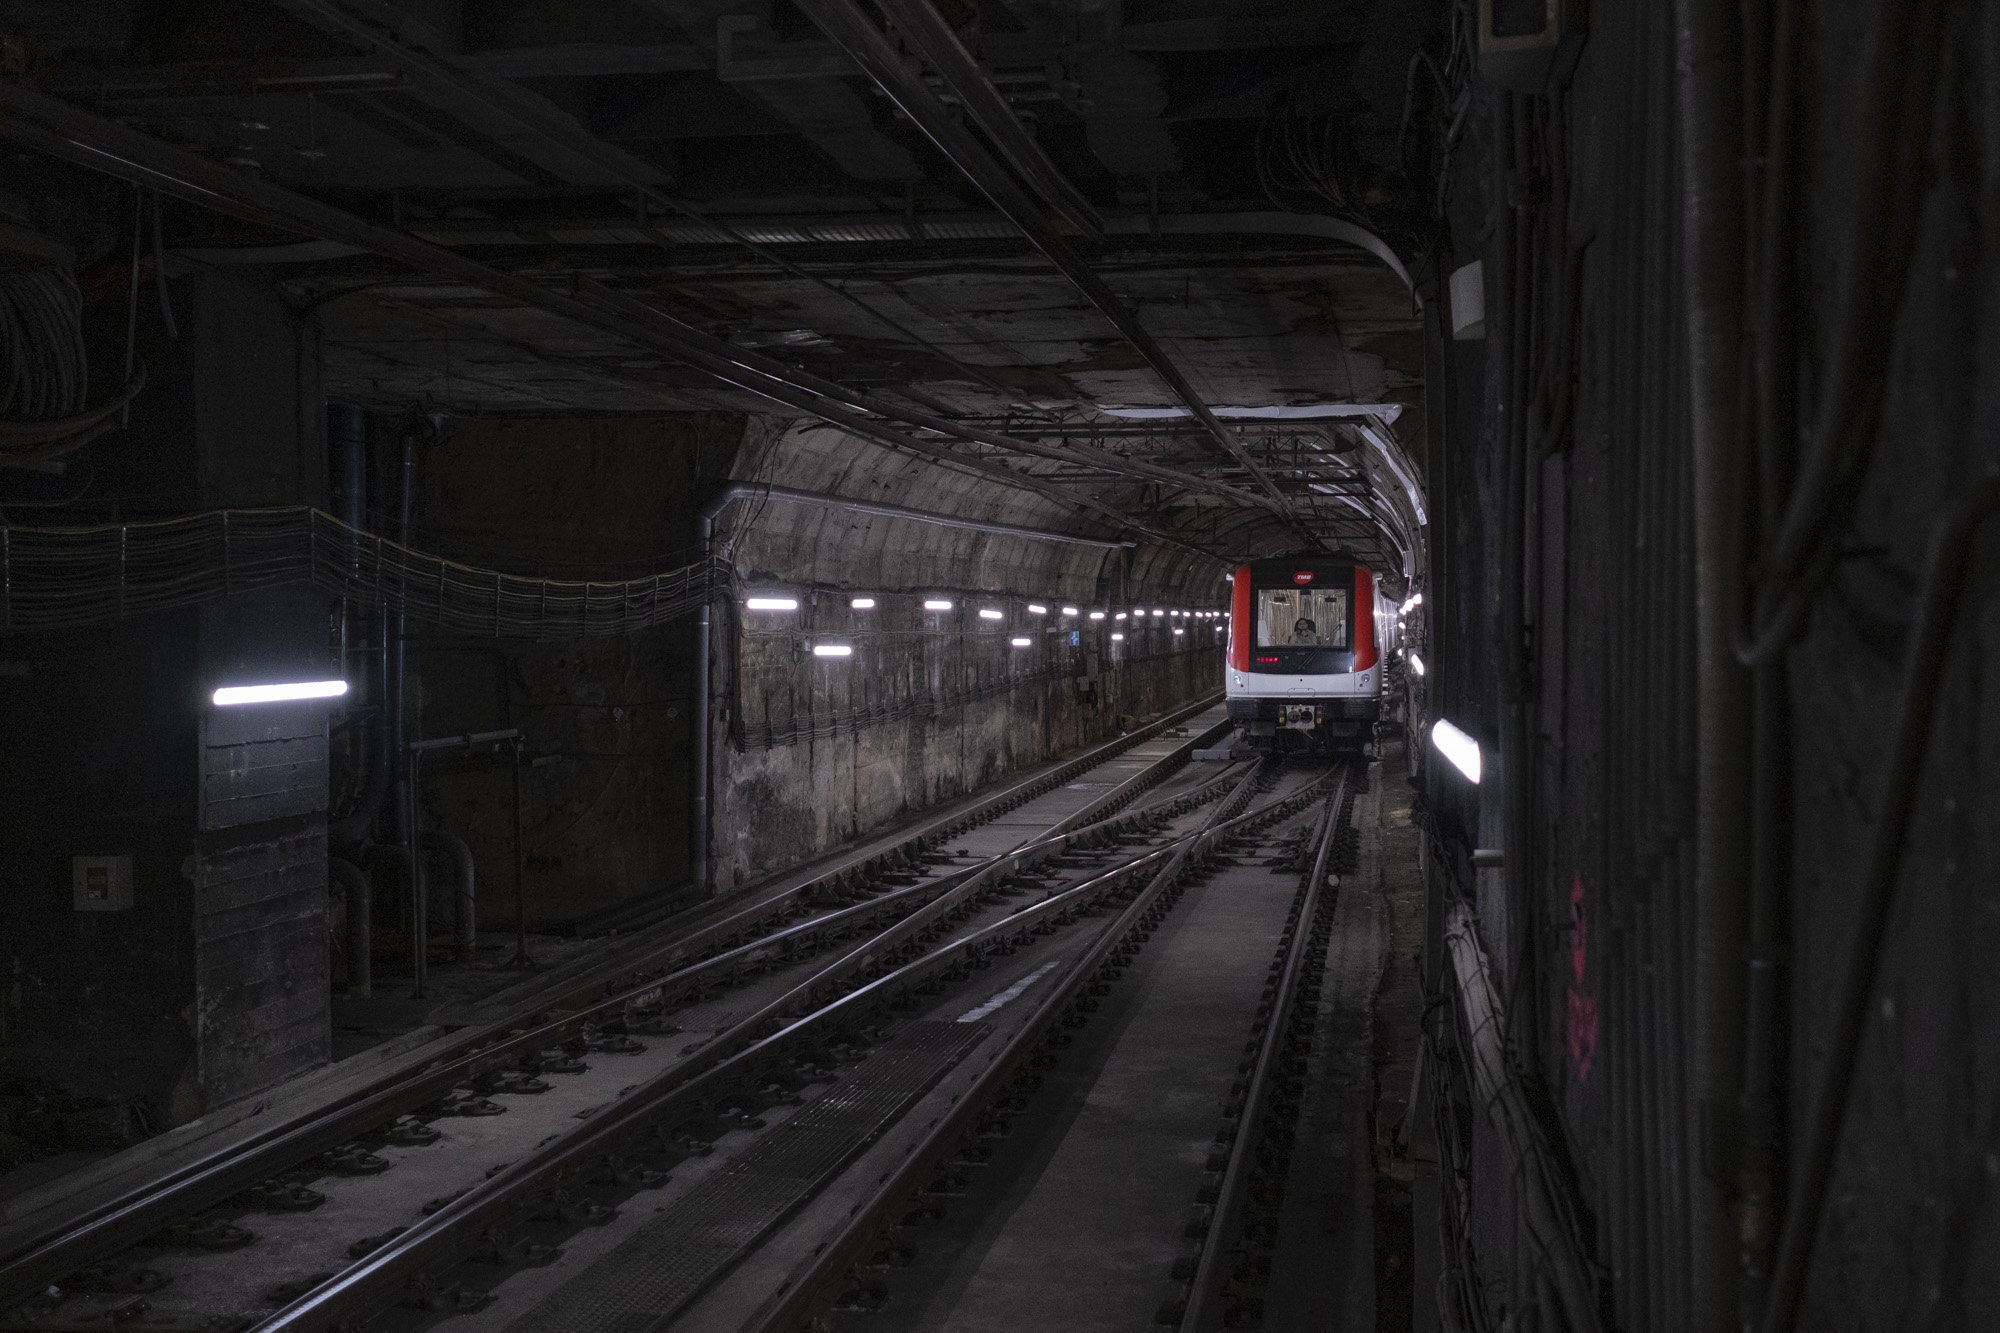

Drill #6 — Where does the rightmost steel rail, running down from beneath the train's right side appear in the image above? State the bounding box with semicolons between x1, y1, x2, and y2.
1180;767;1354;1333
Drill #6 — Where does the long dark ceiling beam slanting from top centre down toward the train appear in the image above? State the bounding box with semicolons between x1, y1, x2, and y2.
796;0;1284;520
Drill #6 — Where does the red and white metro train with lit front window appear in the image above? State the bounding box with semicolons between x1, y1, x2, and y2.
1224;554;1394;749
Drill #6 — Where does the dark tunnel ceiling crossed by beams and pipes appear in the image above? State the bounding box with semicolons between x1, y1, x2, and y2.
0;0;1440;570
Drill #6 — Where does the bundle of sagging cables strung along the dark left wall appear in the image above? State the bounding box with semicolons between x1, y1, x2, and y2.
0;504;726;638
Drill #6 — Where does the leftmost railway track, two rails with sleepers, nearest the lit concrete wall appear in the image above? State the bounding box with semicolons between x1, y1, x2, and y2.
0;705;1228;1333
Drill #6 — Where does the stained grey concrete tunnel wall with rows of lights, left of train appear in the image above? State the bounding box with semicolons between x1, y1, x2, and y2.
710;420;1224;891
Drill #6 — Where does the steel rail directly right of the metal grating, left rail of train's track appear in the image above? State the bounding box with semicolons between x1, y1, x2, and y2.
746;756;1334;1333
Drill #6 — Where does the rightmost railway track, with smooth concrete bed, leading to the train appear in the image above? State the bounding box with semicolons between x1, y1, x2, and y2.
708;769;1356;1333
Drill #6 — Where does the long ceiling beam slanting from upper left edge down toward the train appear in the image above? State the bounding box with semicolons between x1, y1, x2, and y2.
0;82;1214;554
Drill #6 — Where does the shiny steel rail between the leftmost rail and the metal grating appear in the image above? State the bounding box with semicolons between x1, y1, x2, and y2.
256;756;1318;1333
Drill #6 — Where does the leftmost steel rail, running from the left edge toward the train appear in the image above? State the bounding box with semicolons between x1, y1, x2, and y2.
0;699;1226;1309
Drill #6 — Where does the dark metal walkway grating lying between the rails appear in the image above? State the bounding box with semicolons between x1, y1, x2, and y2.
508;1023;986;1333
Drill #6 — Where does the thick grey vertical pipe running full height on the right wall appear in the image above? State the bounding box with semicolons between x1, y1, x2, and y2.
1674;0;1750;1333
